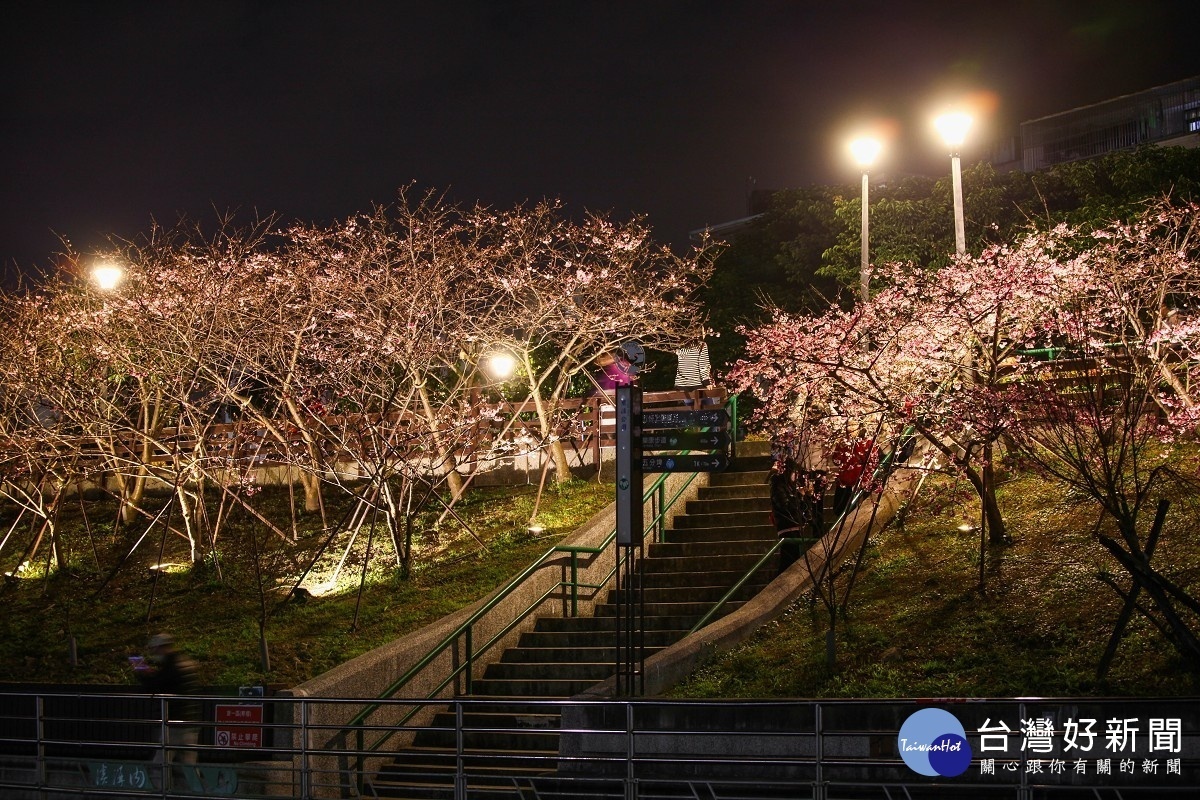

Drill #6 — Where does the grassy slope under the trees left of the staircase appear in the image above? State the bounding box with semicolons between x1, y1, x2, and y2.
0;481;613;686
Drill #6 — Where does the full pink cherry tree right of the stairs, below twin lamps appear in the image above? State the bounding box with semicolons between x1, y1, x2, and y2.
731;235;1079;551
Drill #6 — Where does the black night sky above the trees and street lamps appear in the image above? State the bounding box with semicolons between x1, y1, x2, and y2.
0;0;1200;273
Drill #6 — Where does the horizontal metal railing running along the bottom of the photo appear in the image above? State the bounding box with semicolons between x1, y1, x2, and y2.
0;692;1200;800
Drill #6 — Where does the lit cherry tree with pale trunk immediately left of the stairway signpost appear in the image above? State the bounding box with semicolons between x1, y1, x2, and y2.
469;201;716;481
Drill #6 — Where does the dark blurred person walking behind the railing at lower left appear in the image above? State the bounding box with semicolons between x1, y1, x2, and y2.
133;633;200;777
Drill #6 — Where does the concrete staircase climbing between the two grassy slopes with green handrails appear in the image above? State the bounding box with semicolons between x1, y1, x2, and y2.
371;443;776;799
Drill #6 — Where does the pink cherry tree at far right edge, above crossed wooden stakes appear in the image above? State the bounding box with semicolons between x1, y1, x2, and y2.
1006;201;1200;670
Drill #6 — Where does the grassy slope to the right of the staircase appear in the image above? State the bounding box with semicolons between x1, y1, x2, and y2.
672;465;1200;698
